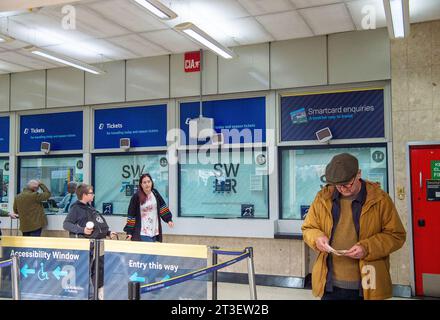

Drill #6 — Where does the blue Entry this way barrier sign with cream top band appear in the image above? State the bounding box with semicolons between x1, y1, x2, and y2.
104;240;207;300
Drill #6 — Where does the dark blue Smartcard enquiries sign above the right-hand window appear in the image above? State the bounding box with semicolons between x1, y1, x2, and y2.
280;89;385;141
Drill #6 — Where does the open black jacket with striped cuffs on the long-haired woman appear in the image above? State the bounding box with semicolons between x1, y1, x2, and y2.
124;189;173;242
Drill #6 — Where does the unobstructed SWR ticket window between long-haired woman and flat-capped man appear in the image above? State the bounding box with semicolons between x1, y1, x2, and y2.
179;150;269;219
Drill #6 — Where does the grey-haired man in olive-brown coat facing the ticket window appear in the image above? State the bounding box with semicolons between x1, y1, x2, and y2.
11;180;51;237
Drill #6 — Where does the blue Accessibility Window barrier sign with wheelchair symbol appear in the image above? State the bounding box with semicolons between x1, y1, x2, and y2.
1;237;90;300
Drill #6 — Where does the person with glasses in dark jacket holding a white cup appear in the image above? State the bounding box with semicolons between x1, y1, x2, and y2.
63;183;116;299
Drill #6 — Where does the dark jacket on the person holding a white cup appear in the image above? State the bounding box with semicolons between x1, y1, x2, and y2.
63;200;110;239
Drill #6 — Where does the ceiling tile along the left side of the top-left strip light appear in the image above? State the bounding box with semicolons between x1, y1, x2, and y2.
87;0;167;32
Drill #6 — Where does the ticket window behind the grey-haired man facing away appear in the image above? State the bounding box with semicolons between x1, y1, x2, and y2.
18;156;83;214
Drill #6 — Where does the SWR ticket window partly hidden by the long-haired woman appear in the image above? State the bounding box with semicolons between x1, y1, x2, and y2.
93;152;169;216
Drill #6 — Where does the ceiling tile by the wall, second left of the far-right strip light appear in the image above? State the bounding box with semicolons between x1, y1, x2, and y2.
299;3;355;35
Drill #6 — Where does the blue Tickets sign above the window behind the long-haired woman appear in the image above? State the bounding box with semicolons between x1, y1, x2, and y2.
95;104;167;149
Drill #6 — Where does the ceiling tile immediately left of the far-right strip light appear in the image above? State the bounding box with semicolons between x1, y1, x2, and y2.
347;0;387;30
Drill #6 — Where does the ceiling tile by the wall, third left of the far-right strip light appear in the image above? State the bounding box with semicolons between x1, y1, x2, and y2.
256;11;313;40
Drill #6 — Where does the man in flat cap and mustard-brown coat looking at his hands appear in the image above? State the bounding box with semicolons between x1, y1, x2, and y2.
302;153;406;300
